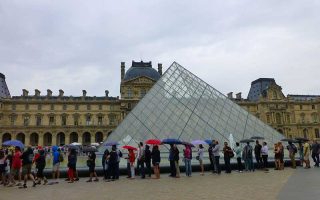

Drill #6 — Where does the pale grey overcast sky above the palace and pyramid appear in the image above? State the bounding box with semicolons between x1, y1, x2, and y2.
0;0;320;97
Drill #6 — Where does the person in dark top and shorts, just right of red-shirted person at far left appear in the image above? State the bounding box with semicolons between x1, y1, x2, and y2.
20;147;36;188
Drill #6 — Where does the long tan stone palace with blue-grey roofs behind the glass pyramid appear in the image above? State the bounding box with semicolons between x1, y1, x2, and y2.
0;61;320;146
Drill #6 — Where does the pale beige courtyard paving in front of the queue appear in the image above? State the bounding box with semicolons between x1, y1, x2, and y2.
0;168;300;200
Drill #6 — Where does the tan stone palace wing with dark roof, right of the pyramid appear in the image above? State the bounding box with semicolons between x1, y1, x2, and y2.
228;79;320;139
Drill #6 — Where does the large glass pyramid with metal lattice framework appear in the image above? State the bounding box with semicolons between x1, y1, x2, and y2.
105;62;283;148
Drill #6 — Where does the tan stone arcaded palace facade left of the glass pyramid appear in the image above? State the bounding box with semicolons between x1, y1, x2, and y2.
0;62;160;146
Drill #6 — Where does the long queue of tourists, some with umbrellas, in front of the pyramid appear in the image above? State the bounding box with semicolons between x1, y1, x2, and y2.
0;140;320;188
